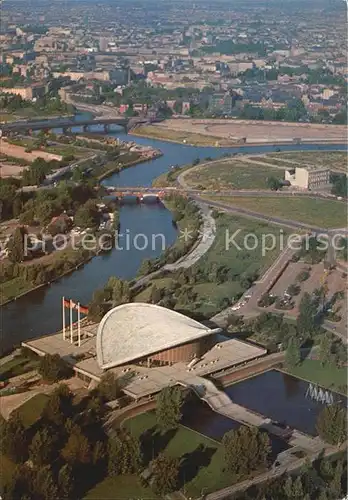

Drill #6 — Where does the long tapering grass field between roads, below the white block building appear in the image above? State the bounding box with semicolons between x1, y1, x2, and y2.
206;196;347;228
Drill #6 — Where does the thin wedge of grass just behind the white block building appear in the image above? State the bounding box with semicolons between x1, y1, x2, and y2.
267;151;348;173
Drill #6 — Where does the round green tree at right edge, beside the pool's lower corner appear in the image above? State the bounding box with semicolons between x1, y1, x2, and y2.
316;404;347;445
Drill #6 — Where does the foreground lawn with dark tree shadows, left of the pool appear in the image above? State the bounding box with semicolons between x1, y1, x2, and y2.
125;412;233;498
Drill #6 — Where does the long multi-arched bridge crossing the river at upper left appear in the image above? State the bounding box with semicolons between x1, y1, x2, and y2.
0;116;160;136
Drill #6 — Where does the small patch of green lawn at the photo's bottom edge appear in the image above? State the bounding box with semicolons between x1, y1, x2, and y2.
85;476;158;500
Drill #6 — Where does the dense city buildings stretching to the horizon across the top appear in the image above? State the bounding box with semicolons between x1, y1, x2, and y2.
1;2;347;123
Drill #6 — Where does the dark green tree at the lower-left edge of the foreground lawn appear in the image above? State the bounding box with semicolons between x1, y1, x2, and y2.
150;453;179;498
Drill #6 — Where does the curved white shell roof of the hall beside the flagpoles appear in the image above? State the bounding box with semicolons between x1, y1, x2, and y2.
97;302;220;369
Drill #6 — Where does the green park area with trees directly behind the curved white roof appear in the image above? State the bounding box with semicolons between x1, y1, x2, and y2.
135;213;286;318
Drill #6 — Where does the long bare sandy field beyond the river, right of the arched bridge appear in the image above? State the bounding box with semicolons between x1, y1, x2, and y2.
154;118;347;143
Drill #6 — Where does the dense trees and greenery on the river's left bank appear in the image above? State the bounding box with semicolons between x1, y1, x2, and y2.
0;179;118;303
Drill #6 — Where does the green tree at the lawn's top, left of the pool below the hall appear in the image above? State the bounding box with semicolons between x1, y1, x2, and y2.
156;386;184;430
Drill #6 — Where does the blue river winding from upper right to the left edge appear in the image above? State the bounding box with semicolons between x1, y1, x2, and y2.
1;119;344;351
